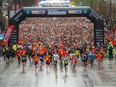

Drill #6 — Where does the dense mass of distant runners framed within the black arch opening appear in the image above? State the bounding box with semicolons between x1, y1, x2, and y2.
19;17;94;46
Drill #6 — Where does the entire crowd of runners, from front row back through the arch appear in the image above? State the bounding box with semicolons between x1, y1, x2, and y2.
3;17;114;71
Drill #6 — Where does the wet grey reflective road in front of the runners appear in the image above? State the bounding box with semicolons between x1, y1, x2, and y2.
0;56;116;87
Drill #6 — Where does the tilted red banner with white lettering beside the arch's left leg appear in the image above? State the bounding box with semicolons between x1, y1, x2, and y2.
2;25;14;45
